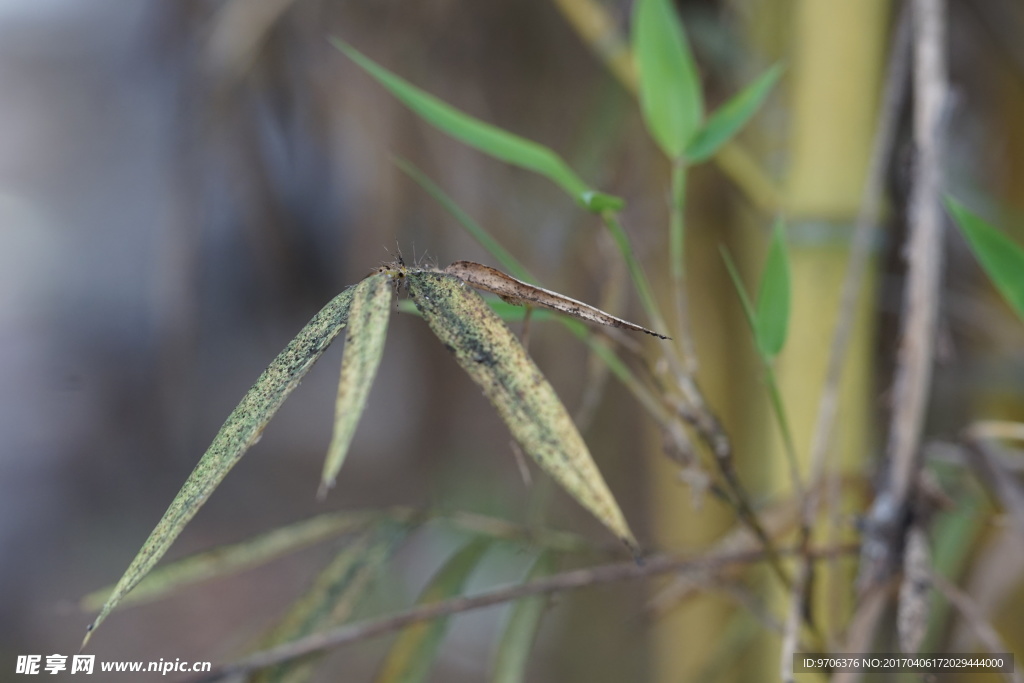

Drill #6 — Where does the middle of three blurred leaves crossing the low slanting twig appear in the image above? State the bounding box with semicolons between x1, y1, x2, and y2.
377;539;489;683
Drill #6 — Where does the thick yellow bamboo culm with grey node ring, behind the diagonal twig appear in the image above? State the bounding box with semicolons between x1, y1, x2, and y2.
744;0;890;673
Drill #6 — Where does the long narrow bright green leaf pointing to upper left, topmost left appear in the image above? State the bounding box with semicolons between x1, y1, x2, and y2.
331;37;625;212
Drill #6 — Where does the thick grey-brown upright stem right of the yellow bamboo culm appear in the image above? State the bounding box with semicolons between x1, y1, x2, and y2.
858;0;948;590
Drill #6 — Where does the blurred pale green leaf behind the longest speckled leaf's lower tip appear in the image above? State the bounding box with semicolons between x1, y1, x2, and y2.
79;512;379;611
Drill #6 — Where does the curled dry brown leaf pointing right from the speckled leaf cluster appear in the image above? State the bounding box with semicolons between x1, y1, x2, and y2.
444;261;669;339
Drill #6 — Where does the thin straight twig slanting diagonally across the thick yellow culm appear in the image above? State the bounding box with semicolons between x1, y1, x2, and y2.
780;6;910;681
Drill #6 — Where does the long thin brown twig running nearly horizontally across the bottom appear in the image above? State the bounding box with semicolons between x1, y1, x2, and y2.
197;545;857;683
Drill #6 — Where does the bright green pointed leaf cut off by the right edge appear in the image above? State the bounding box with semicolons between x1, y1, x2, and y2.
946;197;1024;318
